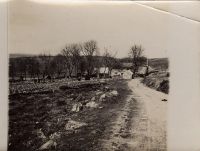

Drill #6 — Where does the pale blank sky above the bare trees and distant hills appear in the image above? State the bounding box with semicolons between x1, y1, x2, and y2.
8;0;195;58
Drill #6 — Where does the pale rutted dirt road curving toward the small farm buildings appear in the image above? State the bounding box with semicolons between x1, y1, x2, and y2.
102;79;167;151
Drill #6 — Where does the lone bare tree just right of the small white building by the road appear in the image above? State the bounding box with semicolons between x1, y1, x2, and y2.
130;45;144;78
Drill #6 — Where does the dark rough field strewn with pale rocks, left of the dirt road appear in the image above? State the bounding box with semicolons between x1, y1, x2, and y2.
8;79;131;151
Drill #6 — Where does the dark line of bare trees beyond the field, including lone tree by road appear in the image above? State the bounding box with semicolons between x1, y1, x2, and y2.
9;40;144;80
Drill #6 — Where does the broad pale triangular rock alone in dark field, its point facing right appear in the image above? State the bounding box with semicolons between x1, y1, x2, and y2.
65;120;87;131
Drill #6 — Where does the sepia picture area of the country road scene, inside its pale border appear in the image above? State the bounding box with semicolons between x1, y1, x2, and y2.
8;0;171;151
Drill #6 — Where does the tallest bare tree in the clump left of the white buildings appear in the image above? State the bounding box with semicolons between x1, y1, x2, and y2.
83;40;98;76
